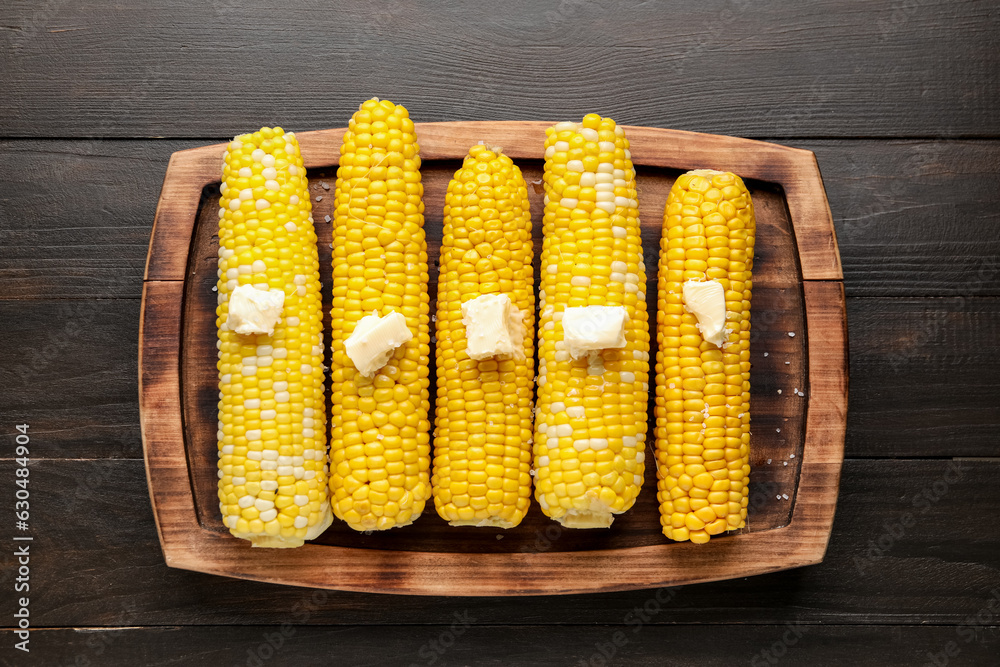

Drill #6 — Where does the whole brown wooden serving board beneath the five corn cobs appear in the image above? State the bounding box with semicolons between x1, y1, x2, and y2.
139;121;847;595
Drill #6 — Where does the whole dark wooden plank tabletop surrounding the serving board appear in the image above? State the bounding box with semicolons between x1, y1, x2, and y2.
0;0;1000;665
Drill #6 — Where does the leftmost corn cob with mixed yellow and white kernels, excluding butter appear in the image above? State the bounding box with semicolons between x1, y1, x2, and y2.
216;127;333;547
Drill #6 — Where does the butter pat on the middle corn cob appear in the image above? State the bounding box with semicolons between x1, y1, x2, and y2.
462;294;524;361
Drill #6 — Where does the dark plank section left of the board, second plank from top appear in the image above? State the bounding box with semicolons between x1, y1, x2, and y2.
0;139;196;299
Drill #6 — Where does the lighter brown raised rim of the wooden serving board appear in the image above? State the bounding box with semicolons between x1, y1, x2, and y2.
138;121;848;596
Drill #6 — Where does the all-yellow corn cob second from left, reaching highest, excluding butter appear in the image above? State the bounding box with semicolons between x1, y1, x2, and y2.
330;99;431;530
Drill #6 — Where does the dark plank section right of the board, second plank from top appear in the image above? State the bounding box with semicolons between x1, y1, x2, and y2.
804;141;1000;297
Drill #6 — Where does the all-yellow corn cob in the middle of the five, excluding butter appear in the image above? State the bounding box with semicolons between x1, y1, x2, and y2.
431;146;535;528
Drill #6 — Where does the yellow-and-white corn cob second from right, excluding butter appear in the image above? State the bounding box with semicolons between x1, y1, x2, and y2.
534;114;649;528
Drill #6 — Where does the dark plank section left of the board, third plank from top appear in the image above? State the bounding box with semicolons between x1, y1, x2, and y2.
0;299;142;458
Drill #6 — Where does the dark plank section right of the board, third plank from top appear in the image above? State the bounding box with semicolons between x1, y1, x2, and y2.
847;297;1000;456
